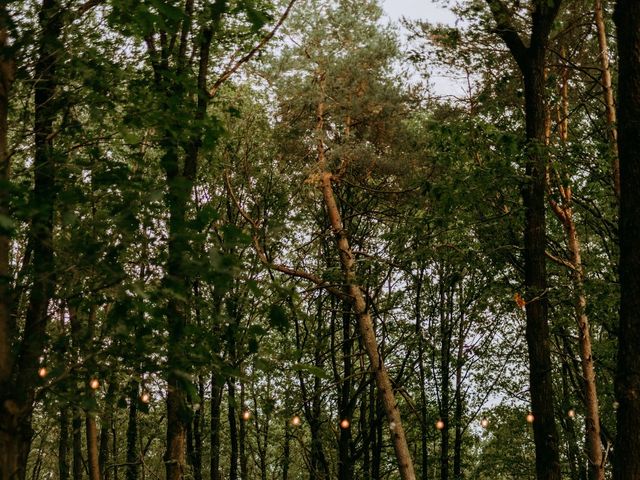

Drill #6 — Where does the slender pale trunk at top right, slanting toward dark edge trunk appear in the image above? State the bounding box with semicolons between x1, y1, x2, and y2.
594;0;620;199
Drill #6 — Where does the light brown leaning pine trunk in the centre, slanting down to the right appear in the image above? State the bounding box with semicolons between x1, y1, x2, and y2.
316;78;416;480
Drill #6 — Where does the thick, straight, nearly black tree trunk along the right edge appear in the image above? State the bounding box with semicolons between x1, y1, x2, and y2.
614;0;640;480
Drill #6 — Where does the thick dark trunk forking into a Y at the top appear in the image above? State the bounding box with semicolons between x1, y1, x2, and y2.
487;0;561;480
